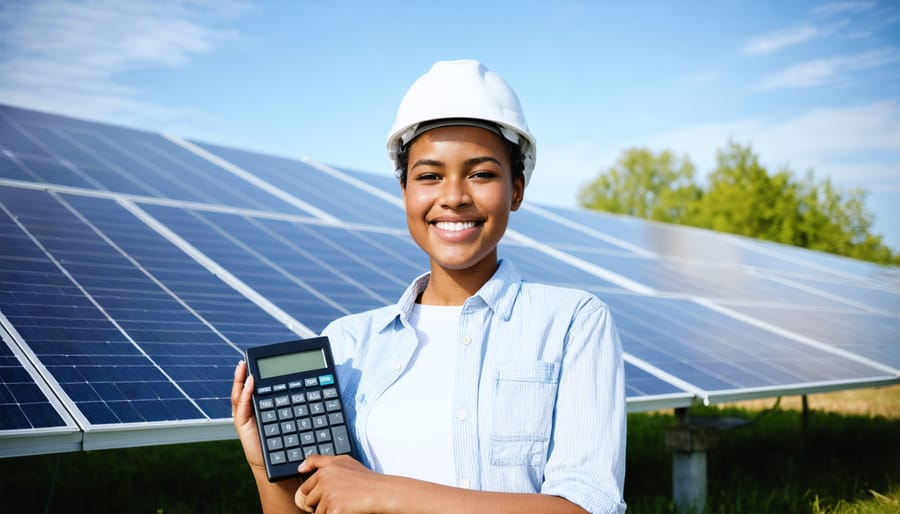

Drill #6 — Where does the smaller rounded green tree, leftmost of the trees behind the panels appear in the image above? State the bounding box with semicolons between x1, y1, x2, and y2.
578;148;700;223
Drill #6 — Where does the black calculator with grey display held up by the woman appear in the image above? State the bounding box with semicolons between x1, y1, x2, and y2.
246;337;355;482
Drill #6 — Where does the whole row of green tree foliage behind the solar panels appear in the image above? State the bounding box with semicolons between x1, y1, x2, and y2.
578;142;900;264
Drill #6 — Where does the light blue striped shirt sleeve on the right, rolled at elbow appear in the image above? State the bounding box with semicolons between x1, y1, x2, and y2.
541;297;626;514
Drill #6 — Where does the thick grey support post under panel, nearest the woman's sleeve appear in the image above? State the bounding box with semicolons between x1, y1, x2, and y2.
666;408;718;514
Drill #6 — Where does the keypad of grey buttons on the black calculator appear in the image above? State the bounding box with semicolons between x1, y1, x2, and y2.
256;375;350;465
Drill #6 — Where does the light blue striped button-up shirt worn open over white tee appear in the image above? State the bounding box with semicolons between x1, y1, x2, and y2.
323;260;625;513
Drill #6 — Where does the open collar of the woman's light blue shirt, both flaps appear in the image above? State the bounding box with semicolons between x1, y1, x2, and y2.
376;259;522;331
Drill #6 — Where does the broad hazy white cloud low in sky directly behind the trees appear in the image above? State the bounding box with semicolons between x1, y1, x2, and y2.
527;100;900;249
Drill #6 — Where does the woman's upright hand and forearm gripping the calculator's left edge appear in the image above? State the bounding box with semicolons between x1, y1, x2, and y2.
231;361;300;513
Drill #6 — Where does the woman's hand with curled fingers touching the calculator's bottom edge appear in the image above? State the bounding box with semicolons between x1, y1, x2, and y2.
294;455;394;514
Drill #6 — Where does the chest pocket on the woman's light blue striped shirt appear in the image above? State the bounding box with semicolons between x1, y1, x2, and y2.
491;361;559;466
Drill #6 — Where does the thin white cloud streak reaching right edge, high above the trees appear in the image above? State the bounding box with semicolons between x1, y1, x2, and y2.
759;47;900;89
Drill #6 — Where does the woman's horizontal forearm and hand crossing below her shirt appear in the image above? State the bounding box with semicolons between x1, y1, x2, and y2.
296;455;585;514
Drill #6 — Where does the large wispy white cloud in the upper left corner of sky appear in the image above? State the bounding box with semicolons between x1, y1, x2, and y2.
0;0;243;125
